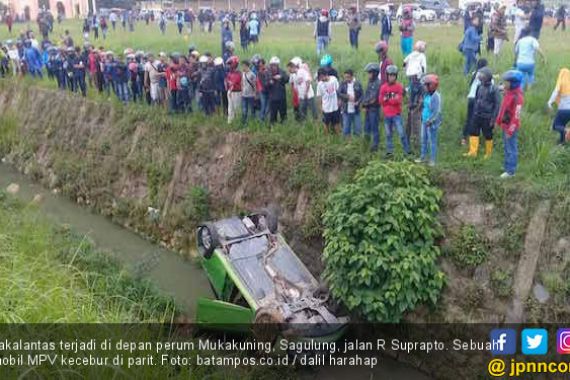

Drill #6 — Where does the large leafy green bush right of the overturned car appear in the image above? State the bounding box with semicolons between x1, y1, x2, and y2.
323;161;444;322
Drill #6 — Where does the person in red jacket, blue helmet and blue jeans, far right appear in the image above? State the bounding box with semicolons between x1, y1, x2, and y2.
497;70;524;178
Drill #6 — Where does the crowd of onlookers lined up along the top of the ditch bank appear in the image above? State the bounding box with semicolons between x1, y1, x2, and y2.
0;3;570;177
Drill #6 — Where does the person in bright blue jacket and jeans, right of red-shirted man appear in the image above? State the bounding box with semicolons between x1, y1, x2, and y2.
416;74;442;166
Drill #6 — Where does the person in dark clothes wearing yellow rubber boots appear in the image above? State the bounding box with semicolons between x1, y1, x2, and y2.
464;67;501;158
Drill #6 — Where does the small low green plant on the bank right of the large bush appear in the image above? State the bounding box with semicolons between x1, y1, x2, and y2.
450;224;489;267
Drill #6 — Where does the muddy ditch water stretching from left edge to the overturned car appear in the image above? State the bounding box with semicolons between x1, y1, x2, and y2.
0;164;212;317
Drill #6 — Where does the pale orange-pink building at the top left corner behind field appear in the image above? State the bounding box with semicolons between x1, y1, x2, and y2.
5;0;97;20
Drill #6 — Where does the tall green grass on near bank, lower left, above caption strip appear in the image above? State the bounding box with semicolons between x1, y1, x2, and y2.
0;193;175;323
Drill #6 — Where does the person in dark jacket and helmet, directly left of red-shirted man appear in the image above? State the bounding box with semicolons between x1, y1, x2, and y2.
360;62;380;152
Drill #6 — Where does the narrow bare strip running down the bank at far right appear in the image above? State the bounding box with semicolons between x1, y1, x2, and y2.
506;201;550;323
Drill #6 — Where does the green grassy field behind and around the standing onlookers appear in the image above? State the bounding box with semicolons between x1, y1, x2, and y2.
0;21;570;190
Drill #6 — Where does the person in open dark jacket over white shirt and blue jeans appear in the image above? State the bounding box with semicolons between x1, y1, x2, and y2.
338;69;364;136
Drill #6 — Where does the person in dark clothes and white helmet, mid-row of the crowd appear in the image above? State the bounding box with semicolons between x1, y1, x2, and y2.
267;57;289;124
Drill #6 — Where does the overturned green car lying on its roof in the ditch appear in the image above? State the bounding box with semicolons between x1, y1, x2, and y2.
196;210;348;340
